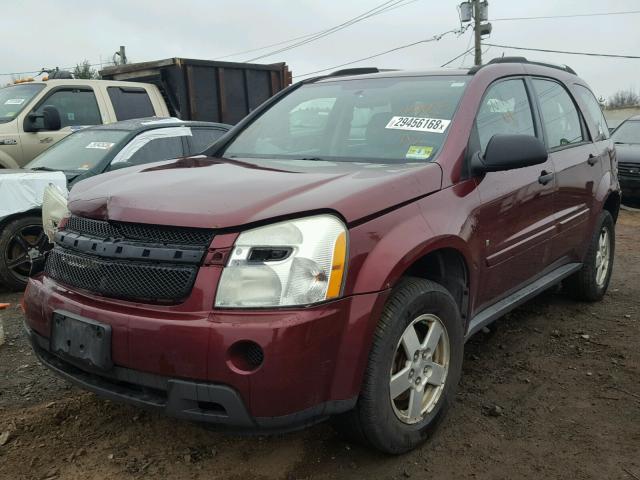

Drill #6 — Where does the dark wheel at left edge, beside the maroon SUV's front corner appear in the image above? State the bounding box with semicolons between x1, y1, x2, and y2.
0;215;51;290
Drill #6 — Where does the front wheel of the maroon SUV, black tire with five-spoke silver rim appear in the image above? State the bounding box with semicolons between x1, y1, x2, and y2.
333;277;464;455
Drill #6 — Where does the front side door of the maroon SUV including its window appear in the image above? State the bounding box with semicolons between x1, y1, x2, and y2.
470;78;556;311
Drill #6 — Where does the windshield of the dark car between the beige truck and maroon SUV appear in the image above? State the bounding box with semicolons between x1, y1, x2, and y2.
25;130;131;170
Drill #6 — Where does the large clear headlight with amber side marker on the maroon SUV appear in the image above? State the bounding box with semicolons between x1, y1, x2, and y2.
216;215;347;308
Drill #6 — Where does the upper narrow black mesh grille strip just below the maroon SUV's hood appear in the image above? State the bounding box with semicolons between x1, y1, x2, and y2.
66;215;213;247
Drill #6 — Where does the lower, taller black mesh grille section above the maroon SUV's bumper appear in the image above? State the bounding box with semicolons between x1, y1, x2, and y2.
45;247;198;303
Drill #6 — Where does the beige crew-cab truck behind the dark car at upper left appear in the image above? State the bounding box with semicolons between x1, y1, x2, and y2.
0;79;169;169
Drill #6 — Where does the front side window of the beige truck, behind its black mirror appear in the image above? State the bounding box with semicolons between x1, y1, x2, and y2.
34;89;102;128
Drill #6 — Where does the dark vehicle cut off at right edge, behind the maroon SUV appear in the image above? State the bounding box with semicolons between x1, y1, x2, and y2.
611;115;640;201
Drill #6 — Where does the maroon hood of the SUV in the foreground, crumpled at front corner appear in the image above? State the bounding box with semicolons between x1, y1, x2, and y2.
69;156;442;228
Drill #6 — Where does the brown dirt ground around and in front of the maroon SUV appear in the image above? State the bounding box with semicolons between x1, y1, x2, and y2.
0;211;640;480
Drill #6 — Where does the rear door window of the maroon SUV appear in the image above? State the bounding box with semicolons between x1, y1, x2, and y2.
533;78;584;148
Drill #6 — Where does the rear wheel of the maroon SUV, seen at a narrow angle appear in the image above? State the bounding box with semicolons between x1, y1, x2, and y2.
564;210;616;302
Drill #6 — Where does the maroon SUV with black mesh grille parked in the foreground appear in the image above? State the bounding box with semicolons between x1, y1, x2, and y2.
25;58;620;453
